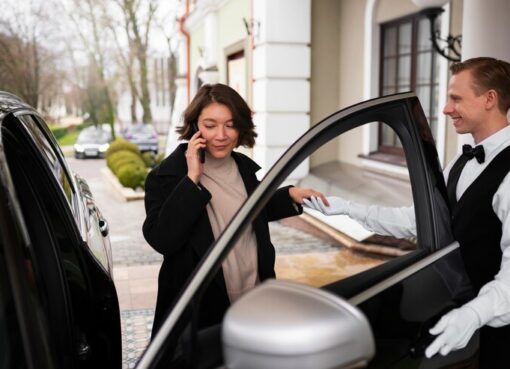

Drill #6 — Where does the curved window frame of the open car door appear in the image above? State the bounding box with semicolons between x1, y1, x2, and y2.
137;92;453;368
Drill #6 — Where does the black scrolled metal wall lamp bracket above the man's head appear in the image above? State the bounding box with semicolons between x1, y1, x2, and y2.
420;7;462;62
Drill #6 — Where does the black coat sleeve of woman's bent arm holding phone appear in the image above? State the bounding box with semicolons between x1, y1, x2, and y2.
143;172;211;256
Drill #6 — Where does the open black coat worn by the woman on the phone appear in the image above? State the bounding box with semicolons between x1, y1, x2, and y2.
143;144;302;334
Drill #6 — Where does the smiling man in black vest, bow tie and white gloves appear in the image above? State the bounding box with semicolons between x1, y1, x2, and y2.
306;57;510;368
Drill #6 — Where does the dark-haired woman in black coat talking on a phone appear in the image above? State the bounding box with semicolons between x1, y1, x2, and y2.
143;84;327;335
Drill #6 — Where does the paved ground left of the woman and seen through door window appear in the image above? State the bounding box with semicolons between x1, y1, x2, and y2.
69;158;386;368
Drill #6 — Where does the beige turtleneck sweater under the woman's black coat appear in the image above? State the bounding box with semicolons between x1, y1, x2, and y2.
200;153;258;303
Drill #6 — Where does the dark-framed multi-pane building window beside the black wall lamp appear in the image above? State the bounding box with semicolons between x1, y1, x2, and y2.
378;14;440;156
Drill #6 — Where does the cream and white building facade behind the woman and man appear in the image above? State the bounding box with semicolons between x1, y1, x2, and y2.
167;0;510;183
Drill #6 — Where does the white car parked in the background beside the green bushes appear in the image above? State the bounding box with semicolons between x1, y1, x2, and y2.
74;125;113;158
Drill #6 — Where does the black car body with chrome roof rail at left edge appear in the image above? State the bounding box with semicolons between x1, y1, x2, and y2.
0;92;122;368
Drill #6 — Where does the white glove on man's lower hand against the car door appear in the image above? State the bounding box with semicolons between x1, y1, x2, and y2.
425;306;480;358
